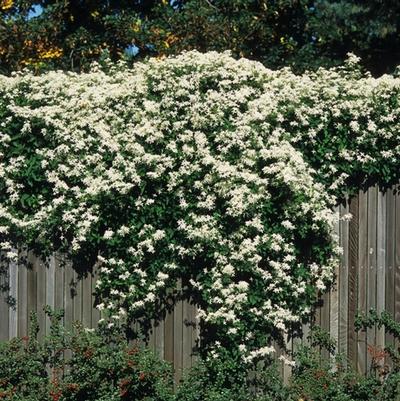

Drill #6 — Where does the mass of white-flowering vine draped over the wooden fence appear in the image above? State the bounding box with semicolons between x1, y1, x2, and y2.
0;52;400;360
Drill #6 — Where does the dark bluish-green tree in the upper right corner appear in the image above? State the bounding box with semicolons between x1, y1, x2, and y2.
308;0;400;75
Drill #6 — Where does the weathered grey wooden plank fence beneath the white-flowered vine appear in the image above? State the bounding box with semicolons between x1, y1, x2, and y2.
0;187;400;379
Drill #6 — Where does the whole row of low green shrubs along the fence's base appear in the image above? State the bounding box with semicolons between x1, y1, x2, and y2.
0;308;400;401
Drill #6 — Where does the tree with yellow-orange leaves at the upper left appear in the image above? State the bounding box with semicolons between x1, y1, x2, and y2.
0;0;156;72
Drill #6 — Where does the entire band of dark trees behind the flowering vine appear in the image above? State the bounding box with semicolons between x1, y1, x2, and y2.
0;0;400;74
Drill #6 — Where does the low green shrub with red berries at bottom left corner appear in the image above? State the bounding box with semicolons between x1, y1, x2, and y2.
0;308;173;401
